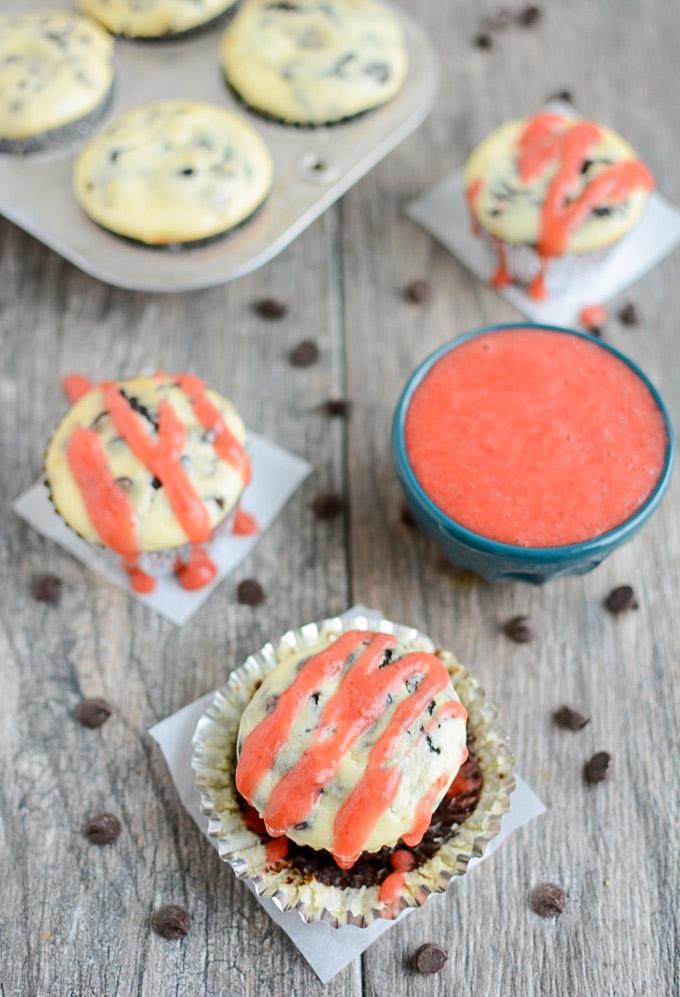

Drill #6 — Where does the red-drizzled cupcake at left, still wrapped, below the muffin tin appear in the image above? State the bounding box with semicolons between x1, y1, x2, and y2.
45;373;251;592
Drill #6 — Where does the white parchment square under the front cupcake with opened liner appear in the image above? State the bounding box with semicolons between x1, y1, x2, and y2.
150;606;545;983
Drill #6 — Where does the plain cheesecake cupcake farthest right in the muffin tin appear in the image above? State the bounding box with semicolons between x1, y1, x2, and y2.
221;0;408;126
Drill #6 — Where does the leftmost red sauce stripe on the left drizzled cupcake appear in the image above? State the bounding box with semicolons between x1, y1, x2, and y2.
66;427;139;566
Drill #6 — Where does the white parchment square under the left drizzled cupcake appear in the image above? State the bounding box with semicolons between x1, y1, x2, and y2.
13;432;312;626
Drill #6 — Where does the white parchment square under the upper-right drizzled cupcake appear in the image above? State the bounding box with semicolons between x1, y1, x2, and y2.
405;130;680;325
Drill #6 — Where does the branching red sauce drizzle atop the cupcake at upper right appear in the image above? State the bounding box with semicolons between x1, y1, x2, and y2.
518;114;654;256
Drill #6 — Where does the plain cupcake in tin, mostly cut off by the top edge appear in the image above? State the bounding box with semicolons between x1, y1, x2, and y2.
77;0;236;39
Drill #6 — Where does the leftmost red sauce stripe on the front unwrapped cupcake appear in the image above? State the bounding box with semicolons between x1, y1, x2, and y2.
236;630;372;802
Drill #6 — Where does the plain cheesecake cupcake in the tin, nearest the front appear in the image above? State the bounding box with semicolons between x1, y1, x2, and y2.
74;100;273;246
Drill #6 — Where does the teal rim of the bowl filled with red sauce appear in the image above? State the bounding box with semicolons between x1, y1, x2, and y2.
392;321;675;563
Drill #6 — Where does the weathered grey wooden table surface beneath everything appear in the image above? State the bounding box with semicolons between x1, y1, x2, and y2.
0;0;680;997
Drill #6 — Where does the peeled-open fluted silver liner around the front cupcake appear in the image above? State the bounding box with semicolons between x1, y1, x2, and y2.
192;616;515;928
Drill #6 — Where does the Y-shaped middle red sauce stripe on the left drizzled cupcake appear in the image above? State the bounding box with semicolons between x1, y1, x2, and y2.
104;386;211;543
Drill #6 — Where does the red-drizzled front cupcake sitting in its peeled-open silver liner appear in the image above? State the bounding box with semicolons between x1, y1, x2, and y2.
193;617;514;927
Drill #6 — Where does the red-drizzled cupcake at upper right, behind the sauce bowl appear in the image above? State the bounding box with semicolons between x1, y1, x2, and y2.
464;111;654;299
